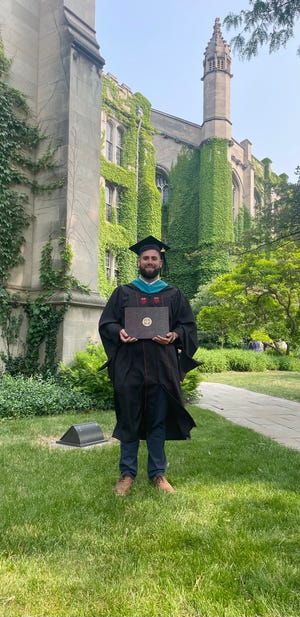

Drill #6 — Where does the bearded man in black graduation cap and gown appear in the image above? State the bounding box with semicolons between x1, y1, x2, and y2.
99;236;198;495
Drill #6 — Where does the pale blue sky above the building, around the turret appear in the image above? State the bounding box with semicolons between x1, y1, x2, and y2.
96;0;300;182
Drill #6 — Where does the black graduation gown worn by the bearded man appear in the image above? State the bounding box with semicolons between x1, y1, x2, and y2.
99;283;198;442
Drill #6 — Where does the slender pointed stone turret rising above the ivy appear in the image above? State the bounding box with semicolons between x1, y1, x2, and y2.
201;18;232;141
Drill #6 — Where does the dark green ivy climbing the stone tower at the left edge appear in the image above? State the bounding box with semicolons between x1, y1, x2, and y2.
0;42;81;375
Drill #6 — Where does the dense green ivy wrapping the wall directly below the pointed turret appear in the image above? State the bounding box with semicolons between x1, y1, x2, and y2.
163;138;233;298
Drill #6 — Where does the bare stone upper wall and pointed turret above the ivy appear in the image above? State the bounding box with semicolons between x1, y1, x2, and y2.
151;19;256;216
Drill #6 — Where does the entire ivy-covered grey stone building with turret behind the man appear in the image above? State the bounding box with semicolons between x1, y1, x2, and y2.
0;0;286;362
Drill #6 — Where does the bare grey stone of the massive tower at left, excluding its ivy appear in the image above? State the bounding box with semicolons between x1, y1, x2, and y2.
0;0;104;362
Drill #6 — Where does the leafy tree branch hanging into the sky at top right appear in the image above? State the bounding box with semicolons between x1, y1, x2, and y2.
224;0;300;60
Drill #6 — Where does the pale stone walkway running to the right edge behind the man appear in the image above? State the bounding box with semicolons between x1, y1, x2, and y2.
199;382;300;451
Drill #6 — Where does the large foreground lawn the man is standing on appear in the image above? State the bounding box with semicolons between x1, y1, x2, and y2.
0;406;300;617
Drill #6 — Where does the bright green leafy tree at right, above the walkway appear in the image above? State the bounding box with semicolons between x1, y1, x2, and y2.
197;242;300;353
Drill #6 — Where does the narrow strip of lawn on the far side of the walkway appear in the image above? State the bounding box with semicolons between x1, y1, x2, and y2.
203;371;300;403
